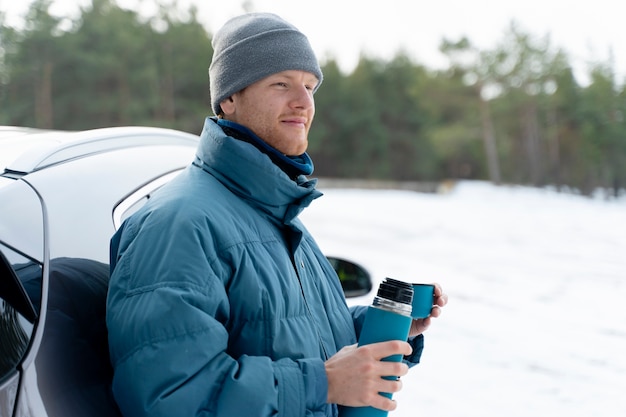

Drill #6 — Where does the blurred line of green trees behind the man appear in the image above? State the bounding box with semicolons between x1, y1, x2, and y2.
0;0;626;195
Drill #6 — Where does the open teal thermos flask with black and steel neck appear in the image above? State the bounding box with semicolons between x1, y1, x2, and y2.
340;278;413;417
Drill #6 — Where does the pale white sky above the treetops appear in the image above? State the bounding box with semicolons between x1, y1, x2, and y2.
0;0;626;82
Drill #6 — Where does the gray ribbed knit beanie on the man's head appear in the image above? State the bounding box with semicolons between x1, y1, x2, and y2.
209;13;323;114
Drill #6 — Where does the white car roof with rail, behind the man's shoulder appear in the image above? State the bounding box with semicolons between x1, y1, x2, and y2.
0;126;199;176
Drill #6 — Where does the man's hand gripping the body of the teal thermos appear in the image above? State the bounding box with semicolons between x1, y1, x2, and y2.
325;340;412;411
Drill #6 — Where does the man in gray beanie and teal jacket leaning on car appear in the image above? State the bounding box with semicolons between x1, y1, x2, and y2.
107;13;446;417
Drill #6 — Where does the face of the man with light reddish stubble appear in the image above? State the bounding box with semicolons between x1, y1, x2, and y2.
220;70;319;156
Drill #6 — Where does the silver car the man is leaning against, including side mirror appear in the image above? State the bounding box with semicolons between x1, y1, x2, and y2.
0;127;372;417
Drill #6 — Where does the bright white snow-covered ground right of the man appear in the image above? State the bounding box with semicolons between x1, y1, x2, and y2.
301;182;626;417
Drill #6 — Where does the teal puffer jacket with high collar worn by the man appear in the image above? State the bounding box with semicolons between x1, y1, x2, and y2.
107;119;363;417
